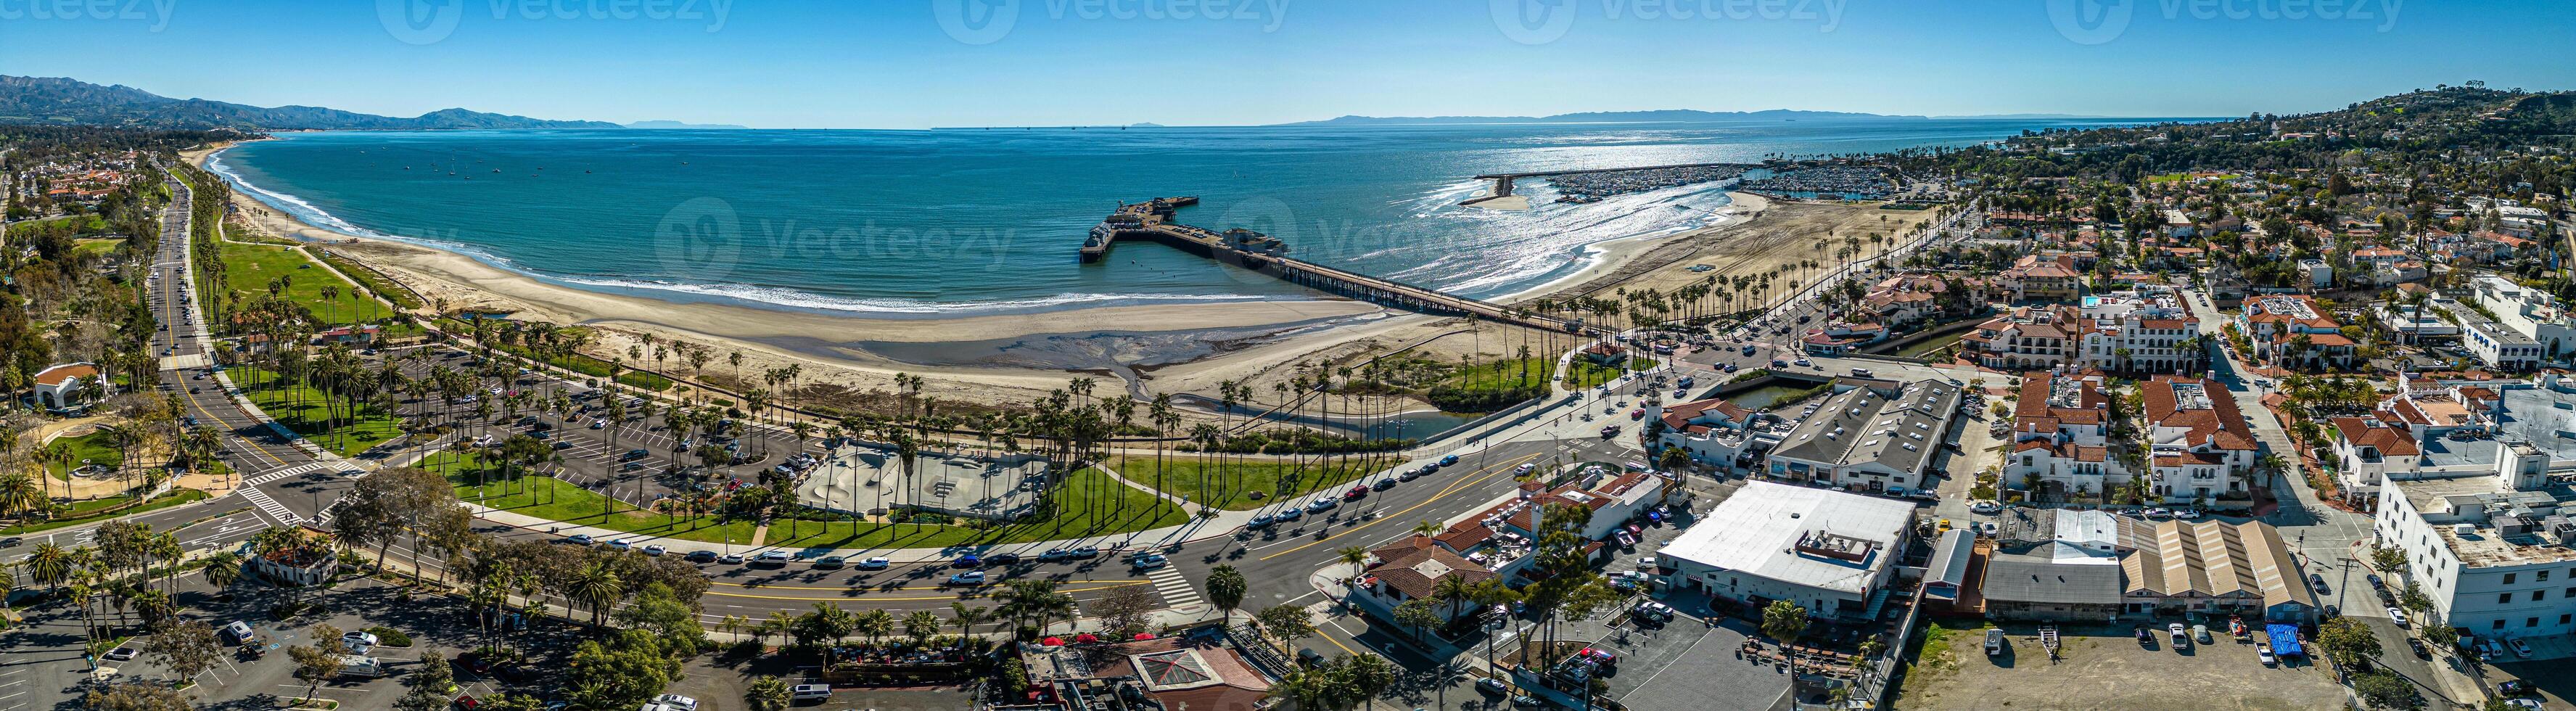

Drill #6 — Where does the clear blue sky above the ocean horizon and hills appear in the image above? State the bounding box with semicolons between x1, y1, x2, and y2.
0;0;2576;129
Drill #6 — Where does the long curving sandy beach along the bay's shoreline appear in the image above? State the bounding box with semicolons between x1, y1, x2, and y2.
186;147;1764;417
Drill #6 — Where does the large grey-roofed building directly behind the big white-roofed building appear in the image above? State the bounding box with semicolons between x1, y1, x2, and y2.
1767;379;1965;492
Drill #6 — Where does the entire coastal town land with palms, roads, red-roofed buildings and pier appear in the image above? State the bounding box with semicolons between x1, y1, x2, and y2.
15;83;2576;711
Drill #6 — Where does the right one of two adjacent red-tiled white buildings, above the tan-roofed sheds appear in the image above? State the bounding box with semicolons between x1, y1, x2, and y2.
2138;376;2257;505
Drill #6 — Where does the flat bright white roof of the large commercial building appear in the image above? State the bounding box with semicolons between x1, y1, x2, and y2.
1659;482;1914;593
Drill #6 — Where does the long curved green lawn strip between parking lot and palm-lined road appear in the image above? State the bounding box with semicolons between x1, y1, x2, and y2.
420;451;1188;548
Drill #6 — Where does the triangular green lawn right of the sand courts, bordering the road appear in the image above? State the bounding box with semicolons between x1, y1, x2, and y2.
1110;453;1396;510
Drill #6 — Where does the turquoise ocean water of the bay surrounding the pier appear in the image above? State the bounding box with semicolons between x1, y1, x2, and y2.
214;121;2174;317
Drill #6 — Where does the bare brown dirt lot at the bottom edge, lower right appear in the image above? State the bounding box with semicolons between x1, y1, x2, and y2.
1896;623;2344;711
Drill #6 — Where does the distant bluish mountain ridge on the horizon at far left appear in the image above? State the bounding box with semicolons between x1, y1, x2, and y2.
0;75;621;131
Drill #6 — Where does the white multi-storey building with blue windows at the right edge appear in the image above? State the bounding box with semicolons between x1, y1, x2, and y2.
2372;440;2576;639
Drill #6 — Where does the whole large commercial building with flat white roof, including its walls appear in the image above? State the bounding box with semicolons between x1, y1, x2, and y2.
1656;482;1914;621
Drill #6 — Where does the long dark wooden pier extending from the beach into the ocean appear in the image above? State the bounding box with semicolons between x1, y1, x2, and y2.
1082;196;1602;335
